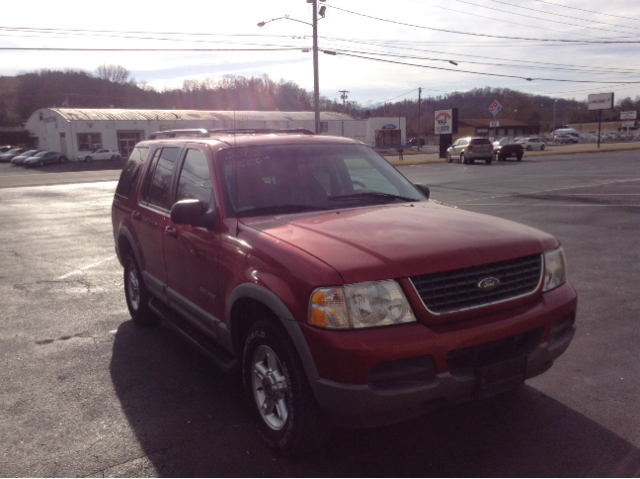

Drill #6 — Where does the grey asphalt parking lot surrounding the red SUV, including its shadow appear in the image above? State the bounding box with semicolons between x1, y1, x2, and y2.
0;150;640;477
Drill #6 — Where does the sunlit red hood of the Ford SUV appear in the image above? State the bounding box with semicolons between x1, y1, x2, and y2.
242;201;558;284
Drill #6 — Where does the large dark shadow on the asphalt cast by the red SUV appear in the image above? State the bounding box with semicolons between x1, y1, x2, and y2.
110;321;640;477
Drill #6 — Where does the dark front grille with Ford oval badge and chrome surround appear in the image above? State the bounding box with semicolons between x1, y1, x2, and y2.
410;254;542;314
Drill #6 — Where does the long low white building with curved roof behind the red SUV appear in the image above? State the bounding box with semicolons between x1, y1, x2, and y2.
25;108;406;160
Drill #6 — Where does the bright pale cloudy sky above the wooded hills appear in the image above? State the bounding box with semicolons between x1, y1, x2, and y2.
0;0;640;107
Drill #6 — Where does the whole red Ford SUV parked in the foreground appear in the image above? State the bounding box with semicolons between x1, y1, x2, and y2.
112;131;577;454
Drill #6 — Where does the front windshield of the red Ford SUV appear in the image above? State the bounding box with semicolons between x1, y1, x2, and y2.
218;144;425;216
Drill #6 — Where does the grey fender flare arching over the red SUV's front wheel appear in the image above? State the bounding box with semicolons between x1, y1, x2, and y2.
226;283;320;382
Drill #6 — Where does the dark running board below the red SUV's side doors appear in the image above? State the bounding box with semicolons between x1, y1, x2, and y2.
149;298;240;374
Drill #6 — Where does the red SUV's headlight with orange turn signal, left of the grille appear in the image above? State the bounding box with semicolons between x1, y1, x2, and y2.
309;280;415;329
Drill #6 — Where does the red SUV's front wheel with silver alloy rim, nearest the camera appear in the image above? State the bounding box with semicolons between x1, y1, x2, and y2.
242;319;330;455
